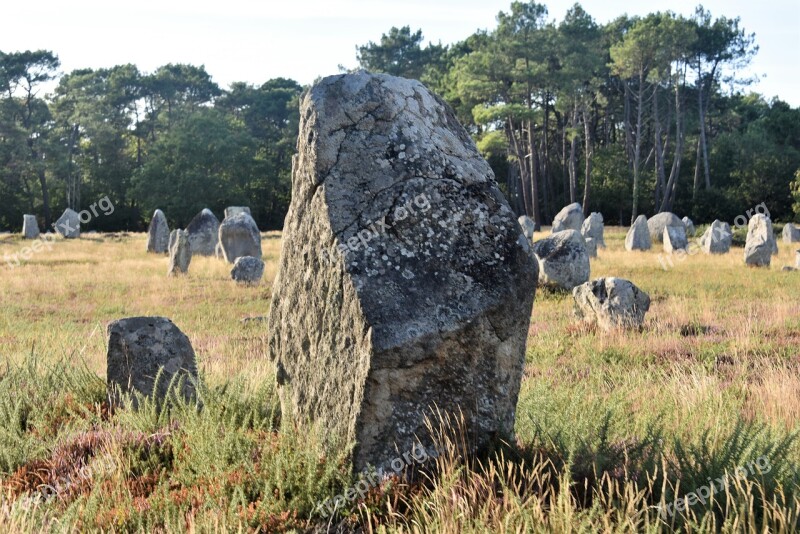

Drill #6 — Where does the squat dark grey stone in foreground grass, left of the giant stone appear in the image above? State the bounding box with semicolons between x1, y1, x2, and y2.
106;317;197;407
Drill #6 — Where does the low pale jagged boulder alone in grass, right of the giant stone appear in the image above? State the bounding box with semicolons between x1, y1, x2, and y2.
572;278;650;331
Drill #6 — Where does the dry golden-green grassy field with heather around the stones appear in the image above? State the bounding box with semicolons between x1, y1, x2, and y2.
0;228;800;532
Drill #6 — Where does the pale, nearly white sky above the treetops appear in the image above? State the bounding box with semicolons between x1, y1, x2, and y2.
0;0;800;106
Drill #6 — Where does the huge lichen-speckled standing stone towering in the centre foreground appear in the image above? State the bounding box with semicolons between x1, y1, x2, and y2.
269;73;537;470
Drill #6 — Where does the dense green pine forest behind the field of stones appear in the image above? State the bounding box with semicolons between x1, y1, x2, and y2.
0;2;800;231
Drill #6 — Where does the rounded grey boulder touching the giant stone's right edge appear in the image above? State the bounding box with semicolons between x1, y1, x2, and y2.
531;230;590;291
